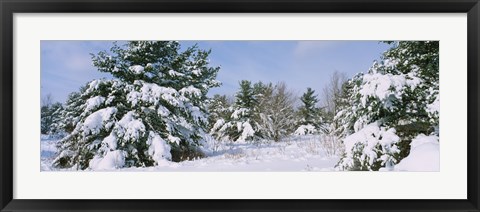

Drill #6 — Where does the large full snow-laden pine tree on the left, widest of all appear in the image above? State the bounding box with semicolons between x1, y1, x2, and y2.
54;41;219;169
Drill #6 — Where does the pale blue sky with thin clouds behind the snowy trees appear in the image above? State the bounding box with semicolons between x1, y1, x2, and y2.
40;41;389;102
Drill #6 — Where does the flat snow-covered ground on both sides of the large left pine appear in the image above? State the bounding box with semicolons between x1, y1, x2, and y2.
41;136;339;172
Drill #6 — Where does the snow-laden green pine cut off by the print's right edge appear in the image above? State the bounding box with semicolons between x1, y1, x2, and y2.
336;41;439;170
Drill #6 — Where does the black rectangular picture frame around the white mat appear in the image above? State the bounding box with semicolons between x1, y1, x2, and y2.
0;0;480;211
